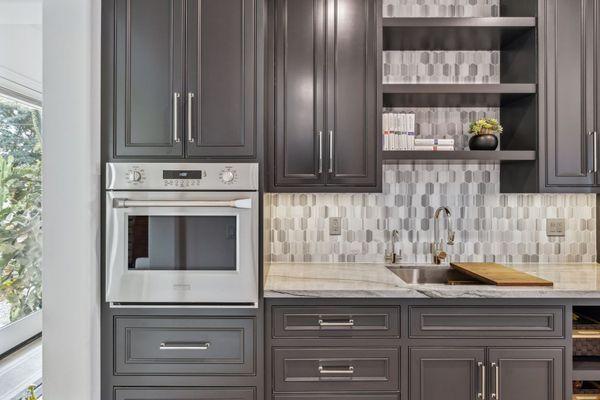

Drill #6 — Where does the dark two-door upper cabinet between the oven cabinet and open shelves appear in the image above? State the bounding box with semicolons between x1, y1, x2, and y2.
269;0;381;191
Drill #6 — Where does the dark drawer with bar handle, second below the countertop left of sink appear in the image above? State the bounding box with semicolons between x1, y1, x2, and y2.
273;347;400;392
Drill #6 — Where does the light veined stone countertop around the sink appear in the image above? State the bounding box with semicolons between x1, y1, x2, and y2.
264;263;600;298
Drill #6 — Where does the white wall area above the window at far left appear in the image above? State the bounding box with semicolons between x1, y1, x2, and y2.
0;0;42;100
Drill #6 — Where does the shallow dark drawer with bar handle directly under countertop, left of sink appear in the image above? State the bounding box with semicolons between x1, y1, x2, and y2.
272;306;400;338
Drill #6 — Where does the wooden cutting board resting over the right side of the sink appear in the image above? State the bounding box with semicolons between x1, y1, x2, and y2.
450;263;554;286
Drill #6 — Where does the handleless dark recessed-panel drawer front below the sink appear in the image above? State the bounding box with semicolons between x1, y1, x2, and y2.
409;306;564;338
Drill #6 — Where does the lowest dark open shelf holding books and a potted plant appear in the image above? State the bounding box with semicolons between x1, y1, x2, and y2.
383;150;535;164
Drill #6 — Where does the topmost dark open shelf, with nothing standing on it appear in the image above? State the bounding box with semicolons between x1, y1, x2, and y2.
383;17;536;50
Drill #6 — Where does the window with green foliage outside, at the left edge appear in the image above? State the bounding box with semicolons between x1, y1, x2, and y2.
0;94;42;354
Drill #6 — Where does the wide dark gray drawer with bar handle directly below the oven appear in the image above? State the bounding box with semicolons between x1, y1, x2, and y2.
114;317;255;375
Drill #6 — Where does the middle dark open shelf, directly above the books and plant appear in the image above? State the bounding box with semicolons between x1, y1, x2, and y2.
383;83;536;107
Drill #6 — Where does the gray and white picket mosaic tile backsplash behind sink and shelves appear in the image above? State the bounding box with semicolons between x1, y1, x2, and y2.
264;0;597;262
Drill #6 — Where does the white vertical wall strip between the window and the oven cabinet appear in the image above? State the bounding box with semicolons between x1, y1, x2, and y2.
43;0;100;400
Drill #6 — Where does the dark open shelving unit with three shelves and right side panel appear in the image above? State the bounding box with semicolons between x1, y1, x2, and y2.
382;0;539;192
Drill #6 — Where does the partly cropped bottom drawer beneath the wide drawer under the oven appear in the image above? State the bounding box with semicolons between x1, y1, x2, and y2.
113;387;255;400
